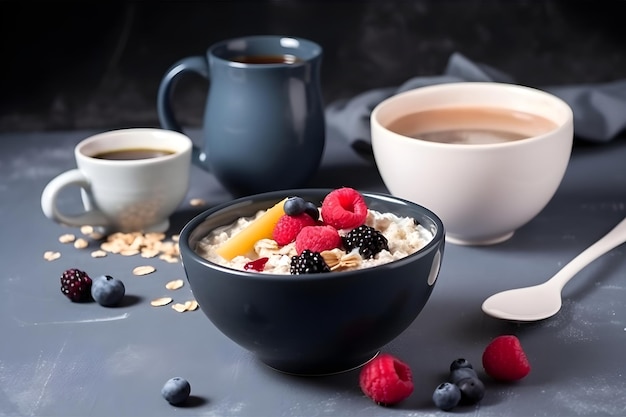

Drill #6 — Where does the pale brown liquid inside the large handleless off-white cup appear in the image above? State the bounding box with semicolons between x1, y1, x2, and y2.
387;107;557;145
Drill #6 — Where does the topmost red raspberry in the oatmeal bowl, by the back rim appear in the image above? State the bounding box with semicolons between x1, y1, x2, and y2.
322;187;367;229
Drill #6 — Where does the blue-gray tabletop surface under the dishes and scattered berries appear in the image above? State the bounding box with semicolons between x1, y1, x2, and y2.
0;127;626;417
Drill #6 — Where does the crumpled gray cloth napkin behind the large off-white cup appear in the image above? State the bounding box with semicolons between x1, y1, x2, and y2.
326;53;626;156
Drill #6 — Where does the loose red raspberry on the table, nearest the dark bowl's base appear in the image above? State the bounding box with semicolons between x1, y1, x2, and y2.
359;353;413;405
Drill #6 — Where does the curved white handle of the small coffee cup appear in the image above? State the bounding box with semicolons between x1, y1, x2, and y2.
41;169;110;227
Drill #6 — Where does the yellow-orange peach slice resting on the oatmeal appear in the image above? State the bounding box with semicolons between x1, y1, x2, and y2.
215;198;287;261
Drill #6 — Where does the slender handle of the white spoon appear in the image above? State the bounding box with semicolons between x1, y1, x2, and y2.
550;218;626;289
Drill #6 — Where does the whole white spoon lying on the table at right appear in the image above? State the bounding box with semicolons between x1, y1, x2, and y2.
482;219;626;321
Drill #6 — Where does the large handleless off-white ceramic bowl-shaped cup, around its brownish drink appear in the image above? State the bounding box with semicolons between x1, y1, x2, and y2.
371;82;573;245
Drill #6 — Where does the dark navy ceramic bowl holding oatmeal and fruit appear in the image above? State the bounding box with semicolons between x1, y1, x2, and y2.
179;189;444;375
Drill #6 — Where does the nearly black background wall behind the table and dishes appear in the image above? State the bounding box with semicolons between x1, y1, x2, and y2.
0;0;626;132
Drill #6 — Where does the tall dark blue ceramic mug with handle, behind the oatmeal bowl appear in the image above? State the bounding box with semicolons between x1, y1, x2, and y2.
157;36;325;195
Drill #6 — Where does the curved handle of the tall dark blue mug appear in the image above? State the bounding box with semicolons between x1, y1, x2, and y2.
157;56;210;169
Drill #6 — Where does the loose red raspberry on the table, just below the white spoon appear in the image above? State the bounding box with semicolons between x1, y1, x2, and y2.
482;335;530;381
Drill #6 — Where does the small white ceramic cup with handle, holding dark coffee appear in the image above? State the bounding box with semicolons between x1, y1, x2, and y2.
41;128;192;232
